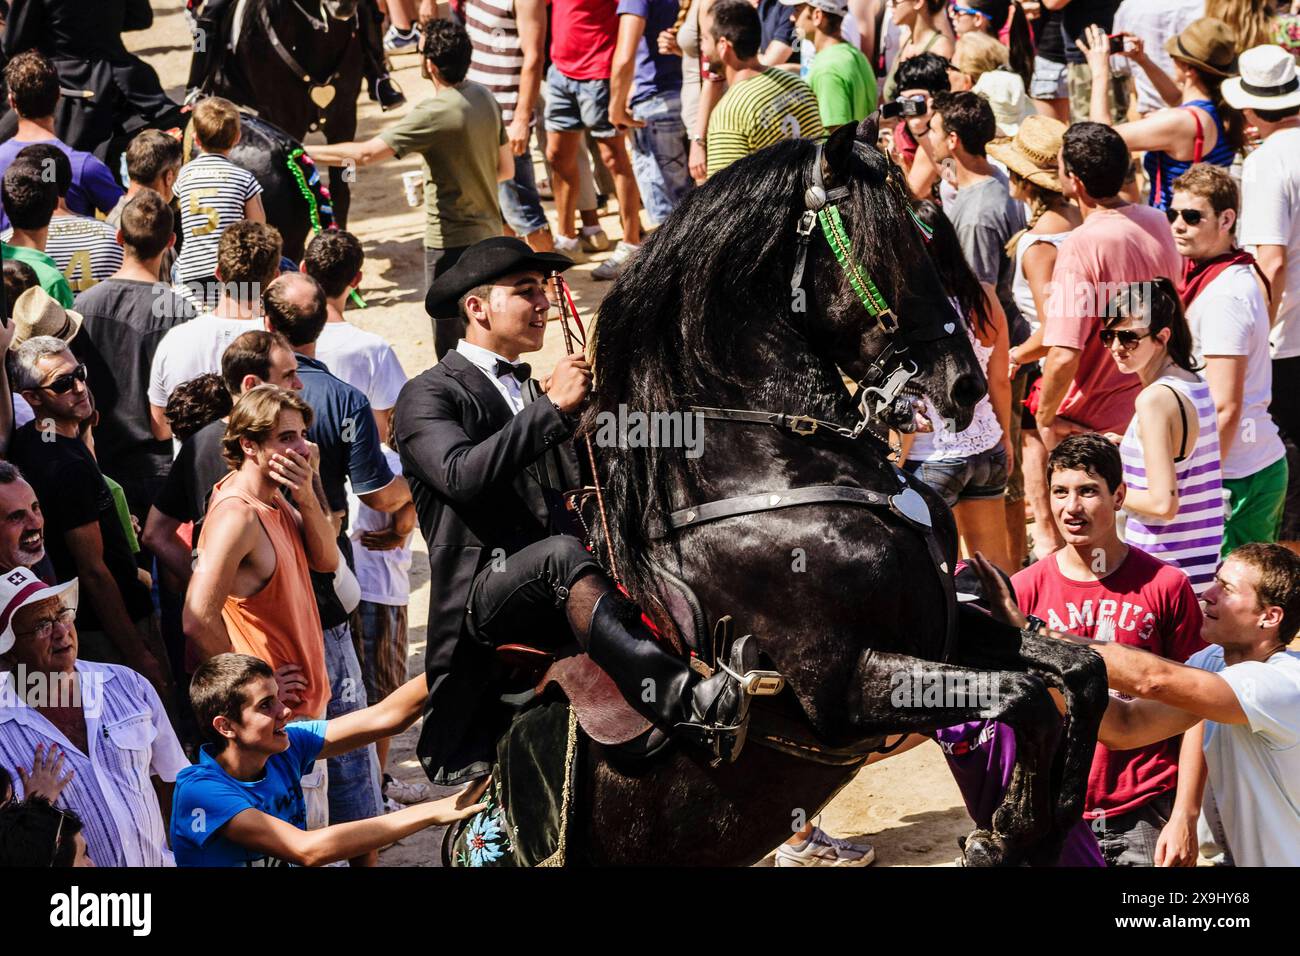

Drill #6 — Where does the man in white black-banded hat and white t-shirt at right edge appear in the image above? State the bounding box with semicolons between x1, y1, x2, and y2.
1223;44;1300;553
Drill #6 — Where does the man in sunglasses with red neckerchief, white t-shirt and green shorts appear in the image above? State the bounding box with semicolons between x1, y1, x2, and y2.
1169;163;1287;555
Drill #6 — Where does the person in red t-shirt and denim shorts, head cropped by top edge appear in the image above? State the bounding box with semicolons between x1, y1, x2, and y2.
543;0;641;278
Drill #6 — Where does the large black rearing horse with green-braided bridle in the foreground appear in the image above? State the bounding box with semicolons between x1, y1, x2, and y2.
580;121;1106;865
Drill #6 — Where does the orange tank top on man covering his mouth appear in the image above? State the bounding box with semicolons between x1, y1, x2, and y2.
199;473;330;718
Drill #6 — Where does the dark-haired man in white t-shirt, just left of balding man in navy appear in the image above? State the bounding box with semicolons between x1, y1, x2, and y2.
150;220;281;440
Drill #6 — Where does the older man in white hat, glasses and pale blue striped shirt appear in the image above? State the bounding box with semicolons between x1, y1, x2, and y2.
0;568;190;866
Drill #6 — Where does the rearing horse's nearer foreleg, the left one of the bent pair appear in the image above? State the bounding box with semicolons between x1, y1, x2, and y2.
850;650;1056;866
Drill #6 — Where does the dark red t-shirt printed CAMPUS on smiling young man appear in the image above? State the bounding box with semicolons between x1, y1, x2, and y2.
1011;548;1205;819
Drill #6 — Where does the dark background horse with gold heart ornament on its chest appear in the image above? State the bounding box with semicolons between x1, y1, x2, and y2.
205;0;361;226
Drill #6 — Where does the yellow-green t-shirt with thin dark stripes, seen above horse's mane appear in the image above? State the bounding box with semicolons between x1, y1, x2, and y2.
706;66;826;176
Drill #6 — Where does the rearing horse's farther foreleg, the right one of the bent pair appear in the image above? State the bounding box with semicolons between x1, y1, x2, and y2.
956;611;1106;862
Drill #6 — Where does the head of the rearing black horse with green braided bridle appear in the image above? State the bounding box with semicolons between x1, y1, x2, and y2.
796;120;987;431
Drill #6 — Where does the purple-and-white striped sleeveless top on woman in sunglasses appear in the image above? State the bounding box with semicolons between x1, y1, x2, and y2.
1119;375;1223;594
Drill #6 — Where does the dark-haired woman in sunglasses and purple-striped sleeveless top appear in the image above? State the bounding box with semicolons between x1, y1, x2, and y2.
1099;278;1223;594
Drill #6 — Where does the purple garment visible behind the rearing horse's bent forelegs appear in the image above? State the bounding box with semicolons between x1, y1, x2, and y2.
935;721;1106;866
